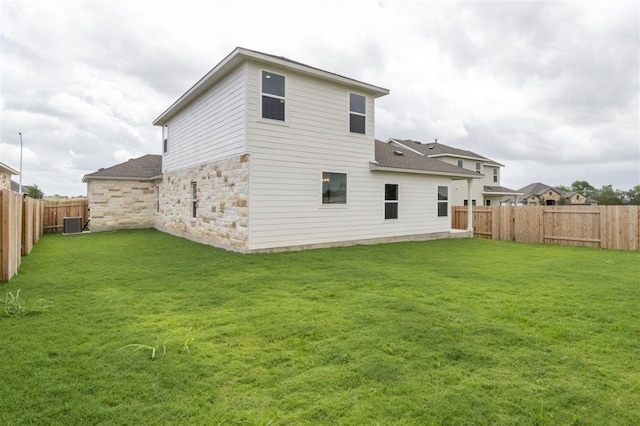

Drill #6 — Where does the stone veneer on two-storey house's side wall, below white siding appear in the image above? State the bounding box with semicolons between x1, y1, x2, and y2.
156;154;249;251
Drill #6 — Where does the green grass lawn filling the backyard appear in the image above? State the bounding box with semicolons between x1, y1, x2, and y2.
0;230;640;425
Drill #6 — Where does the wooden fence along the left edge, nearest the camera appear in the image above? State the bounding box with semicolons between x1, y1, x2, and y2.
0;189;44;282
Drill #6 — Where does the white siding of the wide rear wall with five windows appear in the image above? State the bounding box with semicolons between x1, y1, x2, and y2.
247;65;451;250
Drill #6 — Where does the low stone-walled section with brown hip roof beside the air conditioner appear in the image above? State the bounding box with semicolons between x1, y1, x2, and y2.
82;155;162;231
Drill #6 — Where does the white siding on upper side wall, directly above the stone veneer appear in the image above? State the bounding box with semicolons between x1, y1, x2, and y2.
162;67;247;172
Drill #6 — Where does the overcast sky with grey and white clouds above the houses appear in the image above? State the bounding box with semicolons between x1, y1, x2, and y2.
0;0;640;196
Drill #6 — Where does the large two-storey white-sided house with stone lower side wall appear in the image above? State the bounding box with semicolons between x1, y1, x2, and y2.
84;48;482;252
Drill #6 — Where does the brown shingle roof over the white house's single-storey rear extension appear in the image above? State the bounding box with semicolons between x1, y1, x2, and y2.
372;141;482;179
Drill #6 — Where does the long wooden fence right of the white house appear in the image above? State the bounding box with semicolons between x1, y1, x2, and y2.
451;206;640;250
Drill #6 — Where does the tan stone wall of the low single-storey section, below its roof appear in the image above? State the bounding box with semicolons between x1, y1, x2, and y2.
87;179;156;232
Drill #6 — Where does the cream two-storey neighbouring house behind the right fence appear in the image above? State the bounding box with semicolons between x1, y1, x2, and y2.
388;139;522;206
